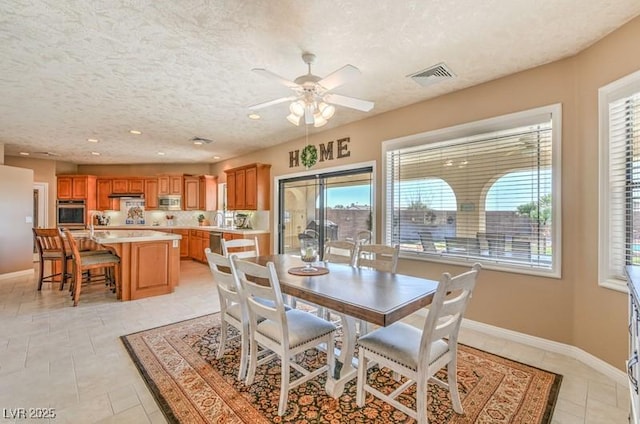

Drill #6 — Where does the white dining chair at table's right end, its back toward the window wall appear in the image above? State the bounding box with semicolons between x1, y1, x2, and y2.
356;264;480;424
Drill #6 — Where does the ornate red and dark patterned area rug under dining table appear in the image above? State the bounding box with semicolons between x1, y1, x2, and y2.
122;314;562;424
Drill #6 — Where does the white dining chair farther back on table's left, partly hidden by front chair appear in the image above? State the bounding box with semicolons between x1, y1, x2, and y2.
204;247;249;381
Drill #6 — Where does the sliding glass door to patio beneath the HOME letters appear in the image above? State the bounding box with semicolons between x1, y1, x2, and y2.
278;167;373;253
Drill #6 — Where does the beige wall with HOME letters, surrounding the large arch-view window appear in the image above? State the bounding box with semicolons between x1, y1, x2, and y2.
212;18;640;369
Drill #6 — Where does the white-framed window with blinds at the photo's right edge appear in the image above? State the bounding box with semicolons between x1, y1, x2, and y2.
598;72;640;291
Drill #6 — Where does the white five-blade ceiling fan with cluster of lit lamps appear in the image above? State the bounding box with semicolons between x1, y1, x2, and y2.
249;53;374;127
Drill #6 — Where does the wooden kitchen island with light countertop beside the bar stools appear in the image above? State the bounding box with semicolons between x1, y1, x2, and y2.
89;229;182;301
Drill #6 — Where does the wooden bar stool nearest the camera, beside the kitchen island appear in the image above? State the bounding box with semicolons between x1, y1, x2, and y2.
64;230;120;306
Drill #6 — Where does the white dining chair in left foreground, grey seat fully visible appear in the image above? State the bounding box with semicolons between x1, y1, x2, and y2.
231;256;336;416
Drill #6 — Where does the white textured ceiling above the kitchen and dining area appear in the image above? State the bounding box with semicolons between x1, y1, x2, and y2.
0;0;640;164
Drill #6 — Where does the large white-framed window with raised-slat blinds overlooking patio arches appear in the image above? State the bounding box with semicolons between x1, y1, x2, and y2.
382;105;561;277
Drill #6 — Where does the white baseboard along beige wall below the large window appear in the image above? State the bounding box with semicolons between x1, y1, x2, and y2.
462;318;629;387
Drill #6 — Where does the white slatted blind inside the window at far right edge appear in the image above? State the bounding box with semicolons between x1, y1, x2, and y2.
608;92;640;280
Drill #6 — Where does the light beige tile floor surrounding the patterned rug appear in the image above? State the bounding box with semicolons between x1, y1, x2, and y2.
0;261;629;424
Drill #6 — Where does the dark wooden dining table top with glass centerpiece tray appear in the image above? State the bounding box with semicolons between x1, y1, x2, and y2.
252;254;438;326
